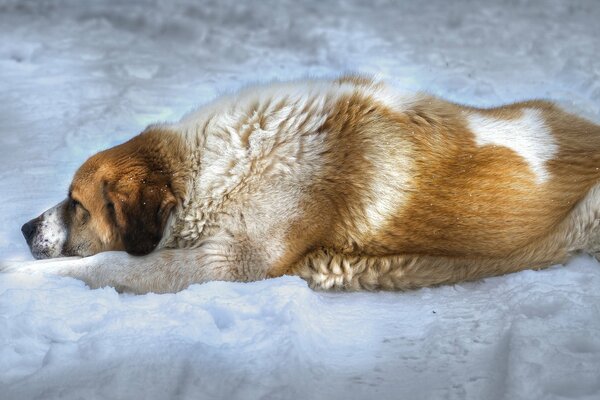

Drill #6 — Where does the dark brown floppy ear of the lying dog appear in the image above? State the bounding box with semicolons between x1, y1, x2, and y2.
104;181;177;256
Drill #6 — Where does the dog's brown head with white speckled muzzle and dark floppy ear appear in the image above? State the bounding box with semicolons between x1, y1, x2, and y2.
21;135;177;259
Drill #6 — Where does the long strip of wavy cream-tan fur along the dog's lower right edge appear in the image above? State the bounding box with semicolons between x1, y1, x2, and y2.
290;185;600;290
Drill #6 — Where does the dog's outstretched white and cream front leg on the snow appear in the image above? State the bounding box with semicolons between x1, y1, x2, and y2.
4;234;267;294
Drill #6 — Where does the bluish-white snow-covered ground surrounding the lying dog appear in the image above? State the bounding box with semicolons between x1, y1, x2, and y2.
0;0;600;400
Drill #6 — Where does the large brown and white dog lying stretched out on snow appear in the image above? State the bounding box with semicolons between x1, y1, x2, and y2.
14;76;600;293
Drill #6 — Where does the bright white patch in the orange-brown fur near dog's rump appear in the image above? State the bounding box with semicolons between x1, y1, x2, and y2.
468;108;558;184
